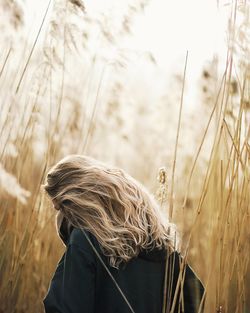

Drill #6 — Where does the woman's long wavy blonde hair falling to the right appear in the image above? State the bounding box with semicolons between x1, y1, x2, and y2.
43;154;176;268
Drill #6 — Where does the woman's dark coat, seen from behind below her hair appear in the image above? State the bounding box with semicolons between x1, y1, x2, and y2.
43;228;204;313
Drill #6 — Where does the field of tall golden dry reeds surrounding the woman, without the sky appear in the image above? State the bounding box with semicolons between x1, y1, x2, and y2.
0;0;250;313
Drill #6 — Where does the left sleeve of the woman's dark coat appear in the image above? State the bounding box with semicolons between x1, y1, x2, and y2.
43;243;95;313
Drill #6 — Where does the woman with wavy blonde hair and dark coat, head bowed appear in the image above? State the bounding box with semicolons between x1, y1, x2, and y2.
43;155;204;313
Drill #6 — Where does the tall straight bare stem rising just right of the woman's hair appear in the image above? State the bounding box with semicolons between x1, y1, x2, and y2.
169;51;188;221
